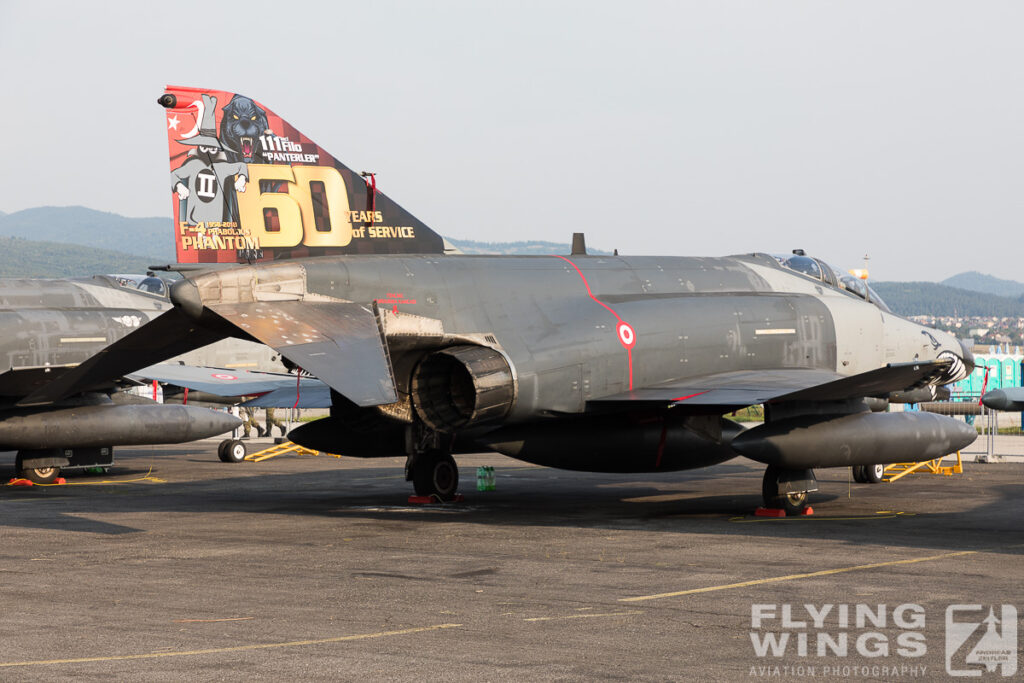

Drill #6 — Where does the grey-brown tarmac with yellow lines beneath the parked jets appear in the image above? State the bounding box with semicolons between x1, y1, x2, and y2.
0;439;1024;681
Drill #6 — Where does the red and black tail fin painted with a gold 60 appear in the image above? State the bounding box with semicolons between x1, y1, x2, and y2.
158;86;444;263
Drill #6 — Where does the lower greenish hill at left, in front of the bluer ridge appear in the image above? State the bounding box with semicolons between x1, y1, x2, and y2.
0;237;154;278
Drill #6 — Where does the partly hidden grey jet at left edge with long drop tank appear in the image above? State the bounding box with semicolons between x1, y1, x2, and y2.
0;275;239;483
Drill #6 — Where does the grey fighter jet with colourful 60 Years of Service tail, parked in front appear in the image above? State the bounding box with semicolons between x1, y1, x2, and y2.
24;87;976;513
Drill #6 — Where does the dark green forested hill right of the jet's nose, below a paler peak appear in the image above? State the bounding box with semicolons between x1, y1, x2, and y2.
871;278;1024;317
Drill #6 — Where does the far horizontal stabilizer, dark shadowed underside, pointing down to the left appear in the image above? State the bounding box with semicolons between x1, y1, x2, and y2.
18;308;223;405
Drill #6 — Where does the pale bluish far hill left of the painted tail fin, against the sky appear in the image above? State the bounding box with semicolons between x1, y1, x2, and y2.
0;206;174;263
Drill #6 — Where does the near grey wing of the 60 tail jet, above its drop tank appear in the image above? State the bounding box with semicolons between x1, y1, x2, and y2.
591;361;948;407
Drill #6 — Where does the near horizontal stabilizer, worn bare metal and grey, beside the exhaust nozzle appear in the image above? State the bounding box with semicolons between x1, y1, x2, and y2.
208;301;398;405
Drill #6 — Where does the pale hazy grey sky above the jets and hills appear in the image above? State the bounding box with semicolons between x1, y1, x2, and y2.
0;0;1024;280
